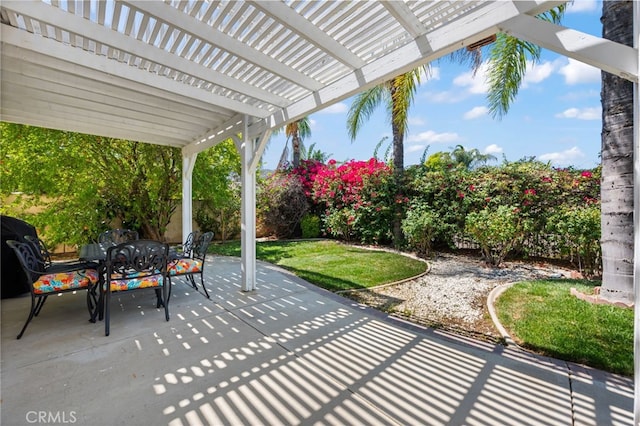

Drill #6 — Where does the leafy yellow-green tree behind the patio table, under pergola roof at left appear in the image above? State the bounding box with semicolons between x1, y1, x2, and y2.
0;123;182;244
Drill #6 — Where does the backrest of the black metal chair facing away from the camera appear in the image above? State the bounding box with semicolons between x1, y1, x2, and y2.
106;240;169;280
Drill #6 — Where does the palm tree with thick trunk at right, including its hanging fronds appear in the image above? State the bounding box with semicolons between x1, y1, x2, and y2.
482;0;634;303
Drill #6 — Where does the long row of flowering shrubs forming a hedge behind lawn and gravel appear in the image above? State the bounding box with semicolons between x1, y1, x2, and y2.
259;152;601;273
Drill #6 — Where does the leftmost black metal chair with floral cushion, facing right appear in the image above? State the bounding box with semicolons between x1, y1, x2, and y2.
7;240;98;339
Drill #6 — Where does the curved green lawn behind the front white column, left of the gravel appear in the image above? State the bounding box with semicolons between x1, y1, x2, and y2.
209;240;427;291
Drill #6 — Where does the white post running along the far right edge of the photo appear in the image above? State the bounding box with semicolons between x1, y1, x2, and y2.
633;1;640;425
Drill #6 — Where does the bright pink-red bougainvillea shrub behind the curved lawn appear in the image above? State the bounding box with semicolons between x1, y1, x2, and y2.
312;158;396;244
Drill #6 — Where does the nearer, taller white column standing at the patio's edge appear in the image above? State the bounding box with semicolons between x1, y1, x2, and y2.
236;117;256;291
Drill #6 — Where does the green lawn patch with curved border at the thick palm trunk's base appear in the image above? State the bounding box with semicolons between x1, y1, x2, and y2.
495;280;633;376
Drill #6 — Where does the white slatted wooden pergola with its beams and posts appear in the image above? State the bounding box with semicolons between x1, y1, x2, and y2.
0;0;640;423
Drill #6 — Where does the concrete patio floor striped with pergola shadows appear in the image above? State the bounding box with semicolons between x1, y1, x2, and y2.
0;256;633;426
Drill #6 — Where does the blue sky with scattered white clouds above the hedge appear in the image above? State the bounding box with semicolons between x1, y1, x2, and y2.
263;0;602;169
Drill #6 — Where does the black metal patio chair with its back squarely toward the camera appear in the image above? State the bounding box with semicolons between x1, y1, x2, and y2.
99;240;171;336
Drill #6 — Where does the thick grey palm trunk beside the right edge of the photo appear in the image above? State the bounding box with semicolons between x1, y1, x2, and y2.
600;0;634;303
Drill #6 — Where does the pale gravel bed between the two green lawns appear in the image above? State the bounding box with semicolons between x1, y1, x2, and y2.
342;253;576;340
